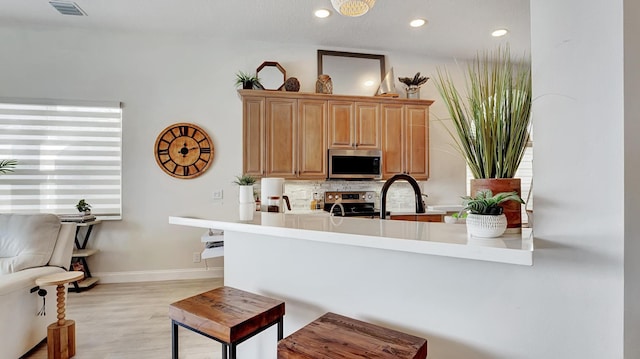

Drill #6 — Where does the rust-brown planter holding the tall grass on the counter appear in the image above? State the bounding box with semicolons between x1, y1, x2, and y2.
470;178;522;233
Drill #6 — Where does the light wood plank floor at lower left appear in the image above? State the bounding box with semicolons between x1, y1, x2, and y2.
23;279;223;359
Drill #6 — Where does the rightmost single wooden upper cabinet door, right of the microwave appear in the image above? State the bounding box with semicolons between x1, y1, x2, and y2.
405;105;429;180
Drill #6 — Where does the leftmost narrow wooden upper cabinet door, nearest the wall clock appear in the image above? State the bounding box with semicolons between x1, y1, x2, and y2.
242;97;265;177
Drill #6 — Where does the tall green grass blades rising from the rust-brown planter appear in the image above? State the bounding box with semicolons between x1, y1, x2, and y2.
435;47;531;178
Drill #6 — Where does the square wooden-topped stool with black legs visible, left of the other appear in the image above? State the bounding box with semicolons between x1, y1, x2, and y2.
169;287;284;359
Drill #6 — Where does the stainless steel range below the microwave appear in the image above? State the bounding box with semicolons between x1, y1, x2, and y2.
324;191;380;218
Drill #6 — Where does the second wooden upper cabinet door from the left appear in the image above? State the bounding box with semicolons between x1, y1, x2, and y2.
265;98;298;178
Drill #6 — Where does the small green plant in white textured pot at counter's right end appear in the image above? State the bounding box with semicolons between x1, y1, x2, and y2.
462;190;524;238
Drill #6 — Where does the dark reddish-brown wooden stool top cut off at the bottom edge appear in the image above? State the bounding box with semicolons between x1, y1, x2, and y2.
278;313;427;359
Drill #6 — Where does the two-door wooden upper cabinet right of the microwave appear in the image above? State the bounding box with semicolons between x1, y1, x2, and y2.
381;104;429;180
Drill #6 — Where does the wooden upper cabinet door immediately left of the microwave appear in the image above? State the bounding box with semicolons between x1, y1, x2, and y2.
298;100;327;179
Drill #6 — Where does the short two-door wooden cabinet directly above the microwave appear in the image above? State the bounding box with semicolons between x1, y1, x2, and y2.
329;101;380;150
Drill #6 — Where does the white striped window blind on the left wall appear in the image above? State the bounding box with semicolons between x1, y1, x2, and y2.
0;99;122;219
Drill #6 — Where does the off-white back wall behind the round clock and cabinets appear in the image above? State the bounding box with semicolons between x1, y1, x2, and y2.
0;27;465;281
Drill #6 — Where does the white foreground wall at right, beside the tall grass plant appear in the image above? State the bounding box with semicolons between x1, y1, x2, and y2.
523;0;625;358
